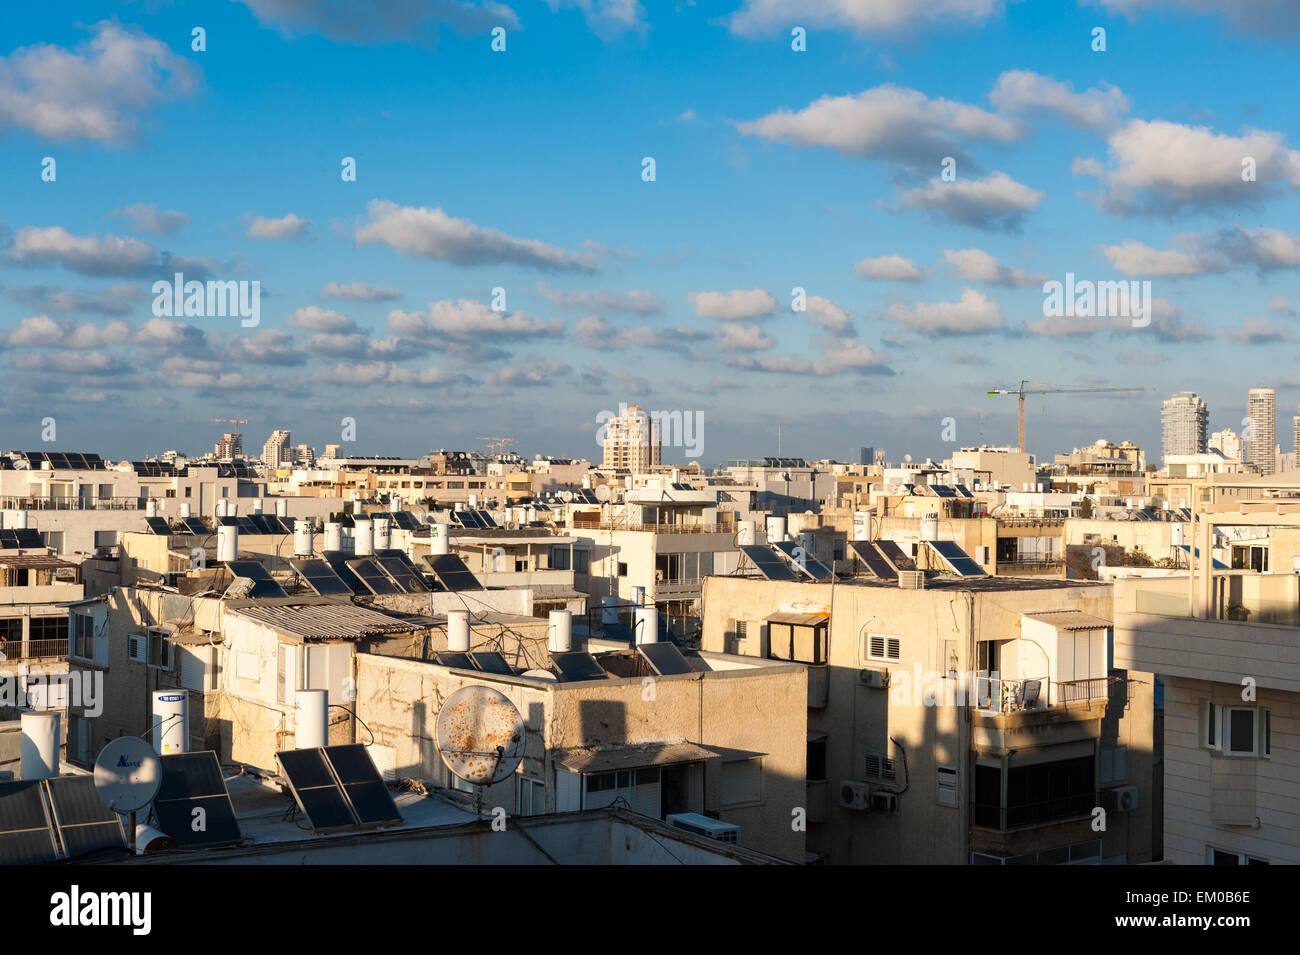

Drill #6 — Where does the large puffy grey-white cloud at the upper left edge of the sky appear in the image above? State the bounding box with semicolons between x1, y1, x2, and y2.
0;21;199;144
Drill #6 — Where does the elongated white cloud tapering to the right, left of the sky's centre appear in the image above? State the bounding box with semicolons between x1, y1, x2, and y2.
355;199;595;272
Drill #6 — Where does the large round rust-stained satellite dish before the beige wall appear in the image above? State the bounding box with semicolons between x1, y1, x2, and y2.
434;683;524;786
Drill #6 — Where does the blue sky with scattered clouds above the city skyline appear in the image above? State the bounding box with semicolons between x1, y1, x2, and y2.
0;0;1300;465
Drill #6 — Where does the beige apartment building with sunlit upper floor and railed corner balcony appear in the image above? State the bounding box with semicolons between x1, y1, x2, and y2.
702;574;1156;864
